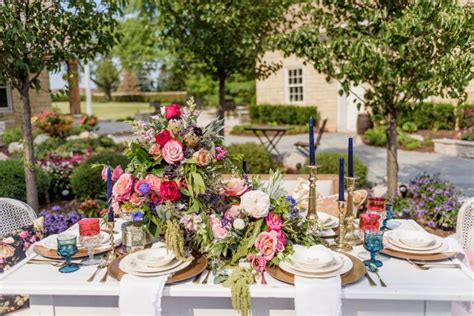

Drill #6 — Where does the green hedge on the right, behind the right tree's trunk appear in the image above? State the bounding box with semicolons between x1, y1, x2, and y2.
398;103;456;132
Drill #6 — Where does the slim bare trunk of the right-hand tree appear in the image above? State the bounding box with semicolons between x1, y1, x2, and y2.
385;108;398;198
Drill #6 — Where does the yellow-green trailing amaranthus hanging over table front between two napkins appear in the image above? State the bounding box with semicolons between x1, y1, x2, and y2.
223;267;253;316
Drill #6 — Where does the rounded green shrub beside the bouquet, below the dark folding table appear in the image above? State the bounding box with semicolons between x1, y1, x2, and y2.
227;143;278;174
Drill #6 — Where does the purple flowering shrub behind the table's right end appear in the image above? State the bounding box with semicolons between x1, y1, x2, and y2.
393;173;461;229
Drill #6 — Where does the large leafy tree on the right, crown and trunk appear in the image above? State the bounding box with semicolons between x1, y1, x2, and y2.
279;0;474;196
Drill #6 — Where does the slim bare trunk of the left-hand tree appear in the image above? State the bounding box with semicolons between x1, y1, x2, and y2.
20;77;39;211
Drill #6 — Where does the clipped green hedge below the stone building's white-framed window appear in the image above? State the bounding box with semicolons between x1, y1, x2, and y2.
249;104;319;125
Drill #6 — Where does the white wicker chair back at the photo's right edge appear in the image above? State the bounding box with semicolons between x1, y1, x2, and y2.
456;198;474;251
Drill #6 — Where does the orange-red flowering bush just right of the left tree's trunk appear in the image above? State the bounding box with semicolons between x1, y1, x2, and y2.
31;111;72;137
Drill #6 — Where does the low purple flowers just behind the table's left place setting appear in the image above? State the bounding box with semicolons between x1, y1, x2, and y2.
39;205;85;235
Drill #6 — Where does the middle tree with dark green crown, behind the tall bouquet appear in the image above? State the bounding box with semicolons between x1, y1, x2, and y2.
158;0;292;131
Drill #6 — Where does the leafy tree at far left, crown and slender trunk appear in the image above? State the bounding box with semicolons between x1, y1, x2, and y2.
0;0;123;210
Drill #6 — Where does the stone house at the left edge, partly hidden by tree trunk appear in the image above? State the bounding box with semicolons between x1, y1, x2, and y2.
0;71;51;134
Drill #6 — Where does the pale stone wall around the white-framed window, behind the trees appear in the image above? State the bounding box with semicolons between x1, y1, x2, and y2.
257;52;338;131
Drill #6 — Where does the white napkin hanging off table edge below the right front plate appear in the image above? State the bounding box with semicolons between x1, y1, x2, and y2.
295;276;342;316
